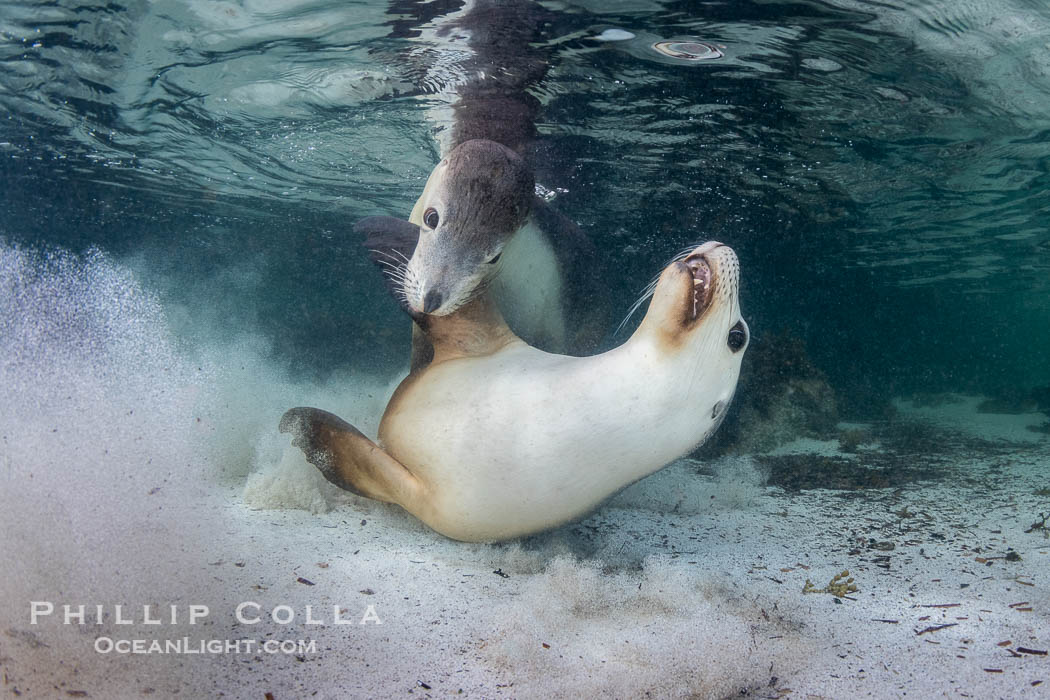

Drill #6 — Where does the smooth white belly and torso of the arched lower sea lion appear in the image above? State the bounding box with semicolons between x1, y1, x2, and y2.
380;343;722;539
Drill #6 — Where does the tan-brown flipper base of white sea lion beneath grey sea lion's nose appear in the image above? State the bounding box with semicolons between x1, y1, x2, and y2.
416;294;521;364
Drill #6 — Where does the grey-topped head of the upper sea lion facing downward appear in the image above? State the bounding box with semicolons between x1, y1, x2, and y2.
403;139;536;316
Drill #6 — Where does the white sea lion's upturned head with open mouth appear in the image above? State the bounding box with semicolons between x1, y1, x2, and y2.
637;241;751;415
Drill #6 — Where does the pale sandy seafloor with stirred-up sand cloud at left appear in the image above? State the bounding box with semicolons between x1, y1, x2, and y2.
0;248;1050;699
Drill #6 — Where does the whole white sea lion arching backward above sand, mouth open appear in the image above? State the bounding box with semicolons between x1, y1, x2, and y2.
280;242;749;542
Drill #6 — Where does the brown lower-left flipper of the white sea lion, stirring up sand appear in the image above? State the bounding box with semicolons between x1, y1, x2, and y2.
278;406;421;506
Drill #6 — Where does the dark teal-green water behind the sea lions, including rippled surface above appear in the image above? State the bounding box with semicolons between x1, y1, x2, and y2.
0;0;1050;417
